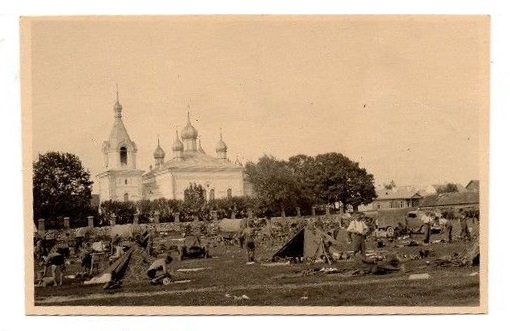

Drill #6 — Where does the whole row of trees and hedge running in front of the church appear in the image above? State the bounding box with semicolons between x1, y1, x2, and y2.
33;152;376;228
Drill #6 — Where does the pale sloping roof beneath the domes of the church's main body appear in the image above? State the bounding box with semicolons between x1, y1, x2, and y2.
144;151;243;176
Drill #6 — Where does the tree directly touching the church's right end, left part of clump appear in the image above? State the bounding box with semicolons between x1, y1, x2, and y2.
245;155;301;218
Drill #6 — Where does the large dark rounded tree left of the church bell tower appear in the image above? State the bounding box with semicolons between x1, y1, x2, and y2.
32;152;93;220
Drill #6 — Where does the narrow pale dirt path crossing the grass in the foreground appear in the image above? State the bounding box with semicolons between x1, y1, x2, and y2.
35;276;407;305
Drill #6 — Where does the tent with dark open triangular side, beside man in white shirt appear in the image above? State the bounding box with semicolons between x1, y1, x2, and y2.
272;228;335;263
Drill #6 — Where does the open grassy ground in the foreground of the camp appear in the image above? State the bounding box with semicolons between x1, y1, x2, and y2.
35;224;480;306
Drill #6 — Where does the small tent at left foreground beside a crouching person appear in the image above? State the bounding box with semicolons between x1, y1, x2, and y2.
85;244;152;284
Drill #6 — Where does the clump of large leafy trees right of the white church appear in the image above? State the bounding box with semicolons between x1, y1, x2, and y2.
245;153;377;214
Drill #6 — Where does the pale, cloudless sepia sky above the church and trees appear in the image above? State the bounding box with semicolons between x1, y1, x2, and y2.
31;16;489;192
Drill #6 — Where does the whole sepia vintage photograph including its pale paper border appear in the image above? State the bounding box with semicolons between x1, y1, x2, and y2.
21;15;490;315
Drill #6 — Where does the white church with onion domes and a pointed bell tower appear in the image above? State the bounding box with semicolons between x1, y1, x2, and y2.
97;93;245;202
